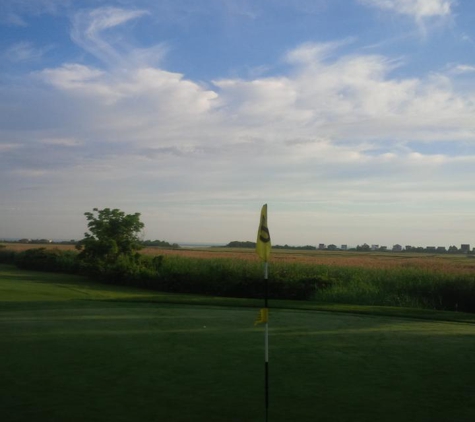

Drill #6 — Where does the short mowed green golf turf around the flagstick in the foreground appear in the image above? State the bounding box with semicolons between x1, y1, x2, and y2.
0;266;475;422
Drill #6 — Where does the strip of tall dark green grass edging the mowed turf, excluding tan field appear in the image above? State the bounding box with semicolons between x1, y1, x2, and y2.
0;248;475;312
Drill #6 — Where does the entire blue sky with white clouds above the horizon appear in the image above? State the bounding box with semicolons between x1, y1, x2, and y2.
0;0;475;247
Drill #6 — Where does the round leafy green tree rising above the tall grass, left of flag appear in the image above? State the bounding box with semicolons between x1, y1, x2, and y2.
76;208;144;264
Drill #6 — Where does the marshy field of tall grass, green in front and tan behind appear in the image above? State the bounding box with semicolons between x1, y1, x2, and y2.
0;245;475;312
